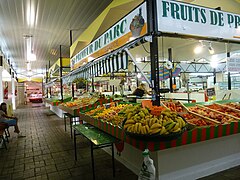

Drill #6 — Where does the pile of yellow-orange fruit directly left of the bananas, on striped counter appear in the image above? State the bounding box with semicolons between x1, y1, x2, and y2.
93;104;132;125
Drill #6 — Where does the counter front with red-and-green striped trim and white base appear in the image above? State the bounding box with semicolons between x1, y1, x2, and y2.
68;101;240;179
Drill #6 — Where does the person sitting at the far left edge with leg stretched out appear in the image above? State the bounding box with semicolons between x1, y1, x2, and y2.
0;102;26;137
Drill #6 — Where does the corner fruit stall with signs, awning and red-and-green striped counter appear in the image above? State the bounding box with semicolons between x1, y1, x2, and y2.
63;0;240;179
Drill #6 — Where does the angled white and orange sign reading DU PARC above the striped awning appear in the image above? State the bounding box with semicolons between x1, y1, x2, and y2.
71;3;147;70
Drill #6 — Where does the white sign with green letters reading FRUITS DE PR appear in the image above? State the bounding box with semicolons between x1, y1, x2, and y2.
156;0;240;41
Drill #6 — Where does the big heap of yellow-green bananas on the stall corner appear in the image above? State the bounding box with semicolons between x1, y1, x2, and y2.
123;107;186;135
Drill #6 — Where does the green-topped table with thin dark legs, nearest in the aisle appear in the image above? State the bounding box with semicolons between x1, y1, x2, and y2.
73;124;118;179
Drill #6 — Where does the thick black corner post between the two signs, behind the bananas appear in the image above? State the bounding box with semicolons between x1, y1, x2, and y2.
146;0;160;106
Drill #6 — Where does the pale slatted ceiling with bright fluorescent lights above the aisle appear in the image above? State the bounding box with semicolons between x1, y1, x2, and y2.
0;0;240;79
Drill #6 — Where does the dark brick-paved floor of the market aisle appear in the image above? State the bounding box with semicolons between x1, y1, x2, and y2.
0;104;137;180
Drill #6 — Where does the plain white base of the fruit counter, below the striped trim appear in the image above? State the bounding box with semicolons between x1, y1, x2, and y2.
105;134;240;180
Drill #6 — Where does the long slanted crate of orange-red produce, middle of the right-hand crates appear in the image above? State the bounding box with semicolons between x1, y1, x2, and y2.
189;106;235;124
